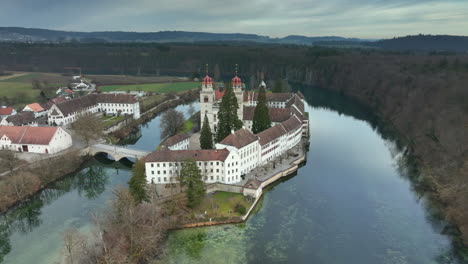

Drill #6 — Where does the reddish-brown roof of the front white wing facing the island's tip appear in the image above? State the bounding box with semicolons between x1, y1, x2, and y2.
145;149;229;162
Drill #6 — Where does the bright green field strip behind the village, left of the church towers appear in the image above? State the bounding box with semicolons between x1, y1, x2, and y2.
99;82;199;93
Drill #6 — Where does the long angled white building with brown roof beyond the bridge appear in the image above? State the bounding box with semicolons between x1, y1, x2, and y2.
48;94;140;126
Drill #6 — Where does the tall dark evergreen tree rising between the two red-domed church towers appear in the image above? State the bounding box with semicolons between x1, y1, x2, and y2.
216;83;242;142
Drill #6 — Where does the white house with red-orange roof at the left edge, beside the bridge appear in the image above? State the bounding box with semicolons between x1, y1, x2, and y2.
0;126;72;154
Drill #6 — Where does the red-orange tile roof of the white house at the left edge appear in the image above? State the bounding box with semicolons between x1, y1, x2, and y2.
0;126;58;145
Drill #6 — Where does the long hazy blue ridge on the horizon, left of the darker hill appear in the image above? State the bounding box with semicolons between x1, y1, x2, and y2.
0;27;364;45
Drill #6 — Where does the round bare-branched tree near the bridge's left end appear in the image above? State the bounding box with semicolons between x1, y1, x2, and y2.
71;115;104;145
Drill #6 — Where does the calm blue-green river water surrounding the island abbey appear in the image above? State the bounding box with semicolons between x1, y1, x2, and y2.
0;88;465;264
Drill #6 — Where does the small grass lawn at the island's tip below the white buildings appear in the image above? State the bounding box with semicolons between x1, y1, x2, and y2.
195;192;251;217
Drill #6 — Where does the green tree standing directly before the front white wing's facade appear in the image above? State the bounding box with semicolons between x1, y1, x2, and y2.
180;159;205;208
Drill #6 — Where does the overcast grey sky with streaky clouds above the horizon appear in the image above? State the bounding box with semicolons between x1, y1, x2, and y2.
0;0;468;38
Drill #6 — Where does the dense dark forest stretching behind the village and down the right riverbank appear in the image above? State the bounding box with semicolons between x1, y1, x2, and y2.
0;43;468;241
